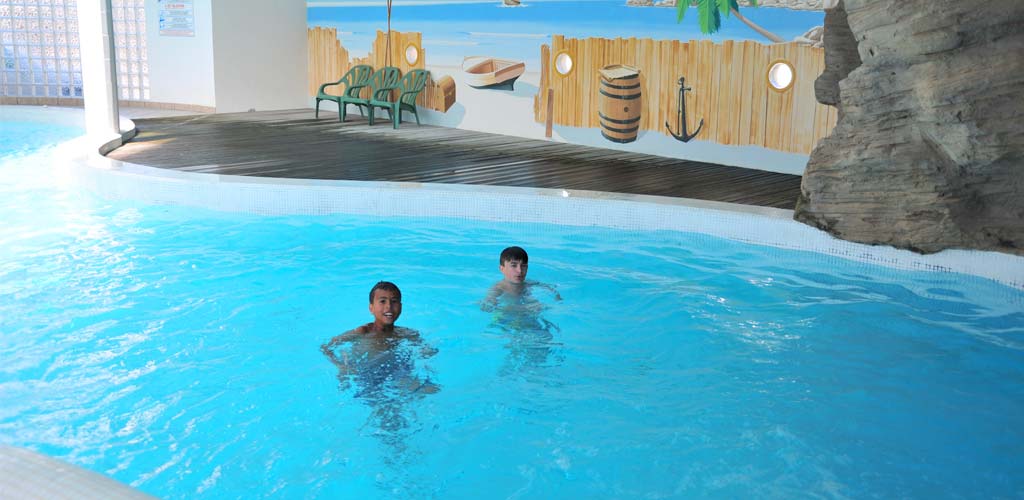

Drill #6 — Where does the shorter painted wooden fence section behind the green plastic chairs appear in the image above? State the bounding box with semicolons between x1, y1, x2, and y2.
306;27;455;112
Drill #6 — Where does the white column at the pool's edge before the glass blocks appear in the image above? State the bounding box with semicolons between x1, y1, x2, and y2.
78;0;121;153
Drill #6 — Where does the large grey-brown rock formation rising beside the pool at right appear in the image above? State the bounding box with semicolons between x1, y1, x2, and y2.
795;0;1024;254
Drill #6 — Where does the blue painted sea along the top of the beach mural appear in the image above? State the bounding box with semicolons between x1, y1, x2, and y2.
307;0;824;72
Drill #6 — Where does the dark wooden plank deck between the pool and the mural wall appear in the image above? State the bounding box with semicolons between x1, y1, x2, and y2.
108;110;800;209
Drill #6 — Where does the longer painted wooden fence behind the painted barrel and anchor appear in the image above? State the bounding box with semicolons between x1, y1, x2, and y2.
534;35;837;154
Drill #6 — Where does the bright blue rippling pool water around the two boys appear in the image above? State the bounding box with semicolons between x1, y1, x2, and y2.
0;116;1024;499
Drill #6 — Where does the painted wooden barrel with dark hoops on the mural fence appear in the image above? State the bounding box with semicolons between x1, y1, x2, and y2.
597;65;641;142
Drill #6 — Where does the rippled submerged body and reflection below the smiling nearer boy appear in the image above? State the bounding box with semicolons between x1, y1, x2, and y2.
321;327;440;457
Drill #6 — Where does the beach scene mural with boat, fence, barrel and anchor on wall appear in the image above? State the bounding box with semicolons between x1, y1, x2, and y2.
307;0;837;174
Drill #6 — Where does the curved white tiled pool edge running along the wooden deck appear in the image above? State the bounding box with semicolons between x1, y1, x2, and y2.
18;105;1024;290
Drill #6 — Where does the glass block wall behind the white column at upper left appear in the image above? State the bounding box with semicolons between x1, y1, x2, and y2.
0;0;150;100
